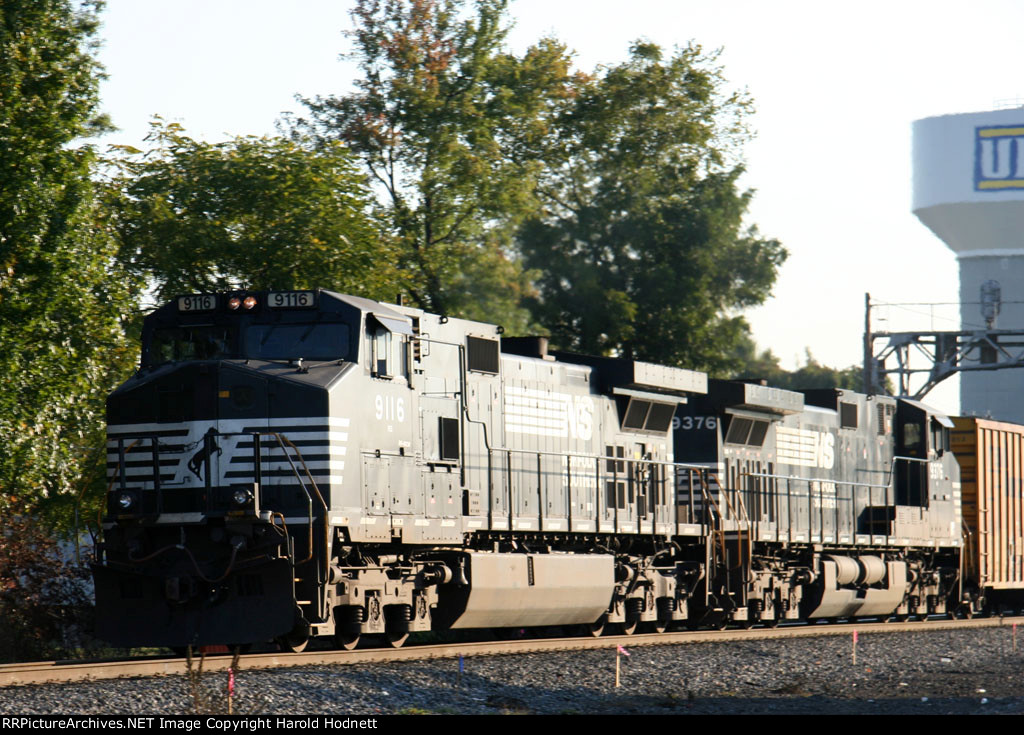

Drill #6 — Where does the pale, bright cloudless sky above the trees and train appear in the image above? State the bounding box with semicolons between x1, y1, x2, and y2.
92;0;1024;413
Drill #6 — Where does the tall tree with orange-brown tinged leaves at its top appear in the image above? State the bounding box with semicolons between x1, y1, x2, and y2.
295;0;569;331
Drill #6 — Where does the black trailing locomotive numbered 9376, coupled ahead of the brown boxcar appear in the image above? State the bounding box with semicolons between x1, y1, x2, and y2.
675;381;962;624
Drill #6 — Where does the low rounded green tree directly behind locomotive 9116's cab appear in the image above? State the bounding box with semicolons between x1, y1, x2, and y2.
110;122;400;301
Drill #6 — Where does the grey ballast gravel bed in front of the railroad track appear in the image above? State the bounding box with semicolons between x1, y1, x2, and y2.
0;625;1024;715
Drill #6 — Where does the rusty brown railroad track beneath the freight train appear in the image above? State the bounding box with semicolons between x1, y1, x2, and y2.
0;617;1024;686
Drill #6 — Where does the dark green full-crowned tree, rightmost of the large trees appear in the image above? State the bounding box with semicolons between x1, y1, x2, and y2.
519;43;786;372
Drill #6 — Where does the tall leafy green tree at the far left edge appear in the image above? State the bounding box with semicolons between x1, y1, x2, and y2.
0;0;136;522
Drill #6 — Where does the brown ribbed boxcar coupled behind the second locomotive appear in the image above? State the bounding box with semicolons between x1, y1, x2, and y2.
950;417;1024;610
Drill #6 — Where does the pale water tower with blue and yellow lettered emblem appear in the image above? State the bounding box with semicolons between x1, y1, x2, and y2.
912;107;1024;423
